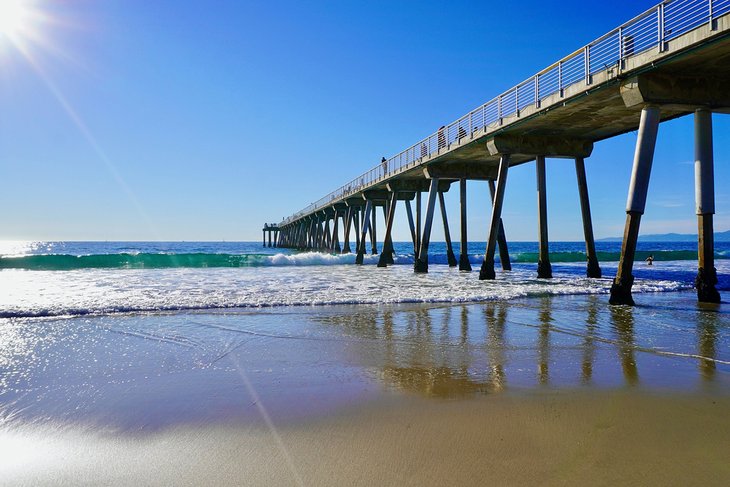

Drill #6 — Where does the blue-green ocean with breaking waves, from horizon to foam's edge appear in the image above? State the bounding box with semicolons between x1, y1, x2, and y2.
0;242;730;318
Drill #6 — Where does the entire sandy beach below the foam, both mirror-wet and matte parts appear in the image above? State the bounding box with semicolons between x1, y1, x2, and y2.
0;293;730;485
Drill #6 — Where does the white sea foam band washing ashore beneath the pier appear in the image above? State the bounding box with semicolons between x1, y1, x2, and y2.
0;260;716;317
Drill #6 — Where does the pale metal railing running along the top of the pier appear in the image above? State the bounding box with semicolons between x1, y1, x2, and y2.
280;0;730;226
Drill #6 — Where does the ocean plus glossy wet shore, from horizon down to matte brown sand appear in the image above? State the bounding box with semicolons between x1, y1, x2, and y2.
0;242;730;434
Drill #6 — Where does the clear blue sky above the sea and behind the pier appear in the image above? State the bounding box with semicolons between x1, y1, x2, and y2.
0;0;730;240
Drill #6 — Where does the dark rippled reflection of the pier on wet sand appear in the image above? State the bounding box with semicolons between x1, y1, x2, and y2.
318;293;730;397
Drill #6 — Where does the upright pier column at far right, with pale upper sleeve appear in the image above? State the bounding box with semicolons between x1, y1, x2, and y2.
695;108;720;303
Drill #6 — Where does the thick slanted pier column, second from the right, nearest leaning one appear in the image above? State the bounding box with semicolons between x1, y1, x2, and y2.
608;105;660;306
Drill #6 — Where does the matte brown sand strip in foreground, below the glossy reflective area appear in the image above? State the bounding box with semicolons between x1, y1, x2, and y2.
2;391;730;486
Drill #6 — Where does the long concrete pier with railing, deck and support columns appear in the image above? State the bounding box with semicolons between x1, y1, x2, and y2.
264;0;730;304
